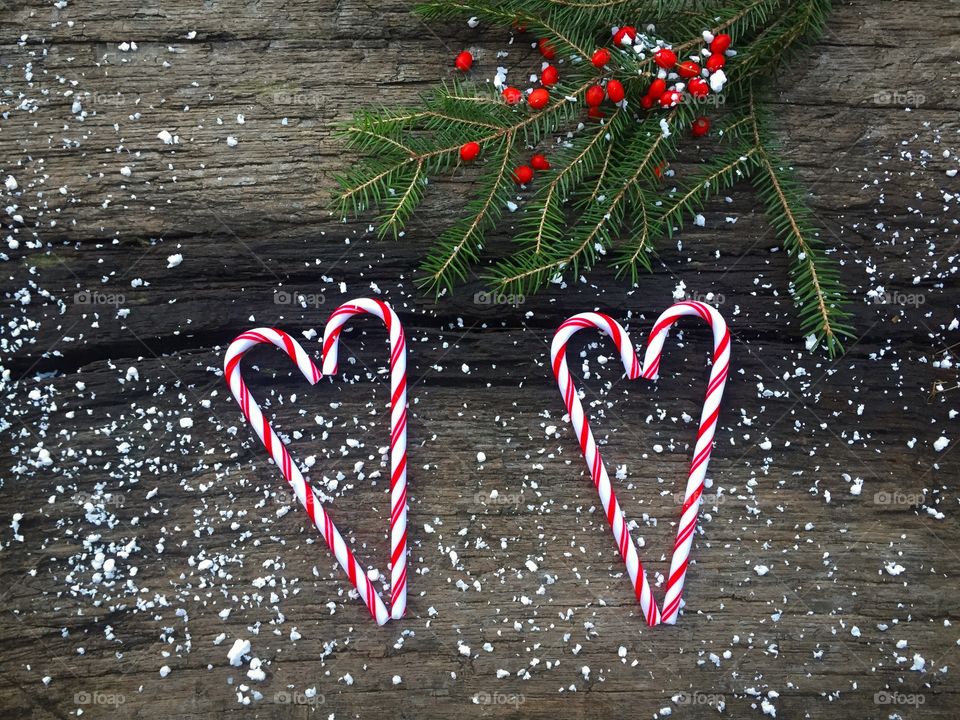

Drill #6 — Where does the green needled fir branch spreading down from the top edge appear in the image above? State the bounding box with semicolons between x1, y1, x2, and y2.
336;0;851;354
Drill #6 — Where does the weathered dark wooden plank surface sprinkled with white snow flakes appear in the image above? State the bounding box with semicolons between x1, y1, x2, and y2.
0;0;960;718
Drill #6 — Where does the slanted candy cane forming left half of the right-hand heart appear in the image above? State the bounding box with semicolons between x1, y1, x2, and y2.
550;312;660;627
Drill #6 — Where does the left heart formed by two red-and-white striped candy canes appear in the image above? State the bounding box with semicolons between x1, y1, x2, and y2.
224;298;407;625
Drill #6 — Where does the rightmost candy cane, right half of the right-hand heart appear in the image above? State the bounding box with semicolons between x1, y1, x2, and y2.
642;302;730;625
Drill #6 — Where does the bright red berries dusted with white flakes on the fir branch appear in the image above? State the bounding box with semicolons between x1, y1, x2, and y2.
454;25;736;163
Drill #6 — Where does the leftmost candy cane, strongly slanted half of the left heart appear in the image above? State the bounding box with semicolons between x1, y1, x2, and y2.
224;328;390;625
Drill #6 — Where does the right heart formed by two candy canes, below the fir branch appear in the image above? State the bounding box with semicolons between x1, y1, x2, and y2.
550;302;730;627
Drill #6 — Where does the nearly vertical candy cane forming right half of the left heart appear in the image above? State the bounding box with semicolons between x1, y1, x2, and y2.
323;298;407;620
